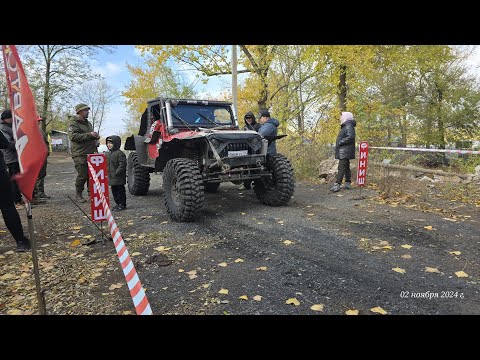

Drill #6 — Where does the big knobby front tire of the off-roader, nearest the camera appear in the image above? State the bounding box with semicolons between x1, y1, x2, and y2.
163;158;205;222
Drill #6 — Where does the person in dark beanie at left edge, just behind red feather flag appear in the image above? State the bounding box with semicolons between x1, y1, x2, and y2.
0;109;23;206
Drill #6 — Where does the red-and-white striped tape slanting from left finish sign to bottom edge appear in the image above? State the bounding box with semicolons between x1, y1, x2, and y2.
88;163;152;315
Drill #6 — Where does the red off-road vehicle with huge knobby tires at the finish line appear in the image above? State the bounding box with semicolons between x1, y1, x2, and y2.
125;98;295;221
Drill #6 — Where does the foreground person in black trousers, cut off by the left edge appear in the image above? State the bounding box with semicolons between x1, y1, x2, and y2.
0;131;30;252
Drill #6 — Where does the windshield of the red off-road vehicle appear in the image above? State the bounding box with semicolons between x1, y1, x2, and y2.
172;104;234;128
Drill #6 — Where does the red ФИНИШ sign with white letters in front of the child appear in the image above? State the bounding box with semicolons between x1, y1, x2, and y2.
87;154;110;222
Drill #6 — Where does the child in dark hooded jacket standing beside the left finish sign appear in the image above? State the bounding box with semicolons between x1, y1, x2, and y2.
106;135;127;211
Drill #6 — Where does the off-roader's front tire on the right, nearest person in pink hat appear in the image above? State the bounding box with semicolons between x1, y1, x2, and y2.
253;154;295;206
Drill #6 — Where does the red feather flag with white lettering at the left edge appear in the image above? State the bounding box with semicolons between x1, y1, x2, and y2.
2;45;48;201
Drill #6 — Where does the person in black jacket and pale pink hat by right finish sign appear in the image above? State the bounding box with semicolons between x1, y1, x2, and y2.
330;111;357;192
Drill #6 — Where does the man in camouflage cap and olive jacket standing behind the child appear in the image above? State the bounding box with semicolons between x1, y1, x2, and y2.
68;103;100;202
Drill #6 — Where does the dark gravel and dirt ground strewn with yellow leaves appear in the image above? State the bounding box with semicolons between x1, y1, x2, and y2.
0;153;480;315
